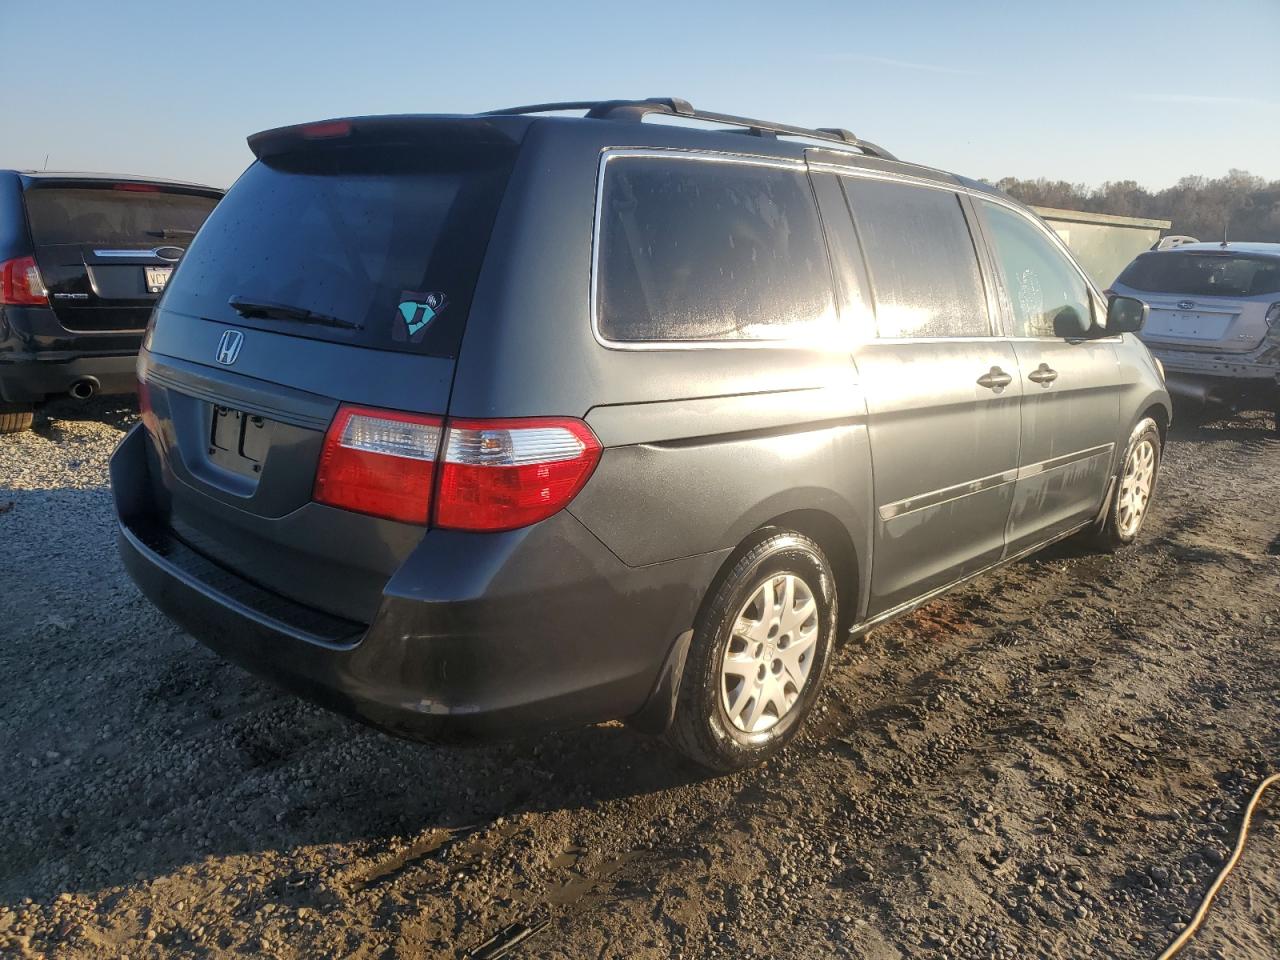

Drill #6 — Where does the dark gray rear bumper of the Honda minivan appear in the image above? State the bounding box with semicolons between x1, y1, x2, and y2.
111;425;726;740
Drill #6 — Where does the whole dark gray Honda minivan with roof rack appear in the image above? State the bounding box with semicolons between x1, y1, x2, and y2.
111;100;1170;771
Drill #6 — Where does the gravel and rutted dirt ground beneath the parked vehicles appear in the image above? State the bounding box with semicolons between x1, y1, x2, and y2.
0;402;1280;959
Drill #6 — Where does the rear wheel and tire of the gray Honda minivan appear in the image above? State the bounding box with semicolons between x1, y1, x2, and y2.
667;530;838;773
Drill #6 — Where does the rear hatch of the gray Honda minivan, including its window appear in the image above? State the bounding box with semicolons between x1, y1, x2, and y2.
141;118;525;622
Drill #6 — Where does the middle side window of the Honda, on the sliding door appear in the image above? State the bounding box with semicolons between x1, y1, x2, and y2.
844;177;991;338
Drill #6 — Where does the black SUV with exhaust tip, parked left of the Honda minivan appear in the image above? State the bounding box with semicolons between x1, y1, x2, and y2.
0;170;223;433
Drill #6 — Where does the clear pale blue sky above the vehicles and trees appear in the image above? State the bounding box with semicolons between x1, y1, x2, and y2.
0;0;1280;188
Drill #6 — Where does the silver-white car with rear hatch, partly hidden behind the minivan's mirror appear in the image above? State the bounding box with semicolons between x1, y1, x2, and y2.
1107;242;1280;435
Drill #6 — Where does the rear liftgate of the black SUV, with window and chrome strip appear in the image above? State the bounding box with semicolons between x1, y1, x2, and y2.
23;177;221;332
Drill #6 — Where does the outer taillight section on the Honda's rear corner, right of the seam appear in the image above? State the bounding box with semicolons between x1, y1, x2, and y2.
435;417;600;530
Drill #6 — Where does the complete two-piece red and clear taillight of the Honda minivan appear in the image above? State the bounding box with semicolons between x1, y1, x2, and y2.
314;406;600;531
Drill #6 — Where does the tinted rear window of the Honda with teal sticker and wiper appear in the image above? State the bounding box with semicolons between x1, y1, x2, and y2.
164;145;515;357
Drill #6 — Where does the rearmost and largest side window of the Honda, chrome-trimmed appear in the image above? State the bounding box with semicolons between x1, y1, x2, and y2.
595;156;835;342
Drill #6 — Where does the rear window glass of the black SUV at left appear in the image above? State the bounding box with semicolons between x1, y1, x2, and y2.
23;187;218;247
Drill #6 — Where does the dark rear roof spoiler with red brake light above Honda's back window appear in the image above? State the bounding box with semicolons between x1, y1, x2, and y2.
247;114;536;160
